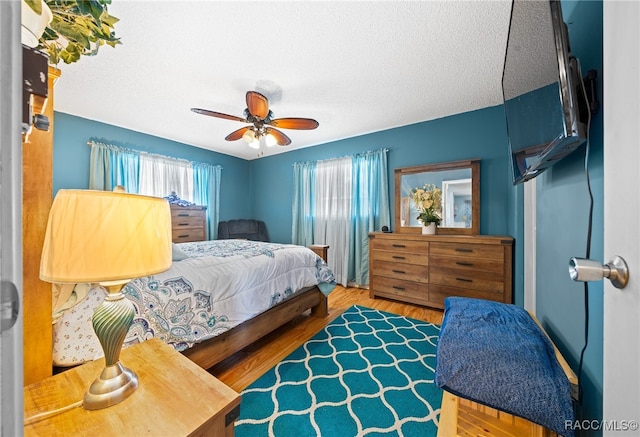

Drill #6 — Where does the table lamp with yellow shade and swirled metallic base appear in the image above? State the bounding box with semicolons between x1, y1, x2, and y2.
40;190;171;410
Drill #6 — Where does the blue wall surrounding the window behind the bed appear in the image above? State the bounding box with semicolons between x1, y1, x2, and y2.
53;112;252;220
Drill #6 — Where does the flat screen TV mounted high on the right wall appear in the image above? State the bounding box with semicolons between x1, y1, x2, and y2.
502;0;588;185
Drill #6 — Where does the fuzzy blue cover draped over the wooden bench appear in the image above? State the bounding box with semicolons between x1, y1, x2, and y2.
436;297;574;436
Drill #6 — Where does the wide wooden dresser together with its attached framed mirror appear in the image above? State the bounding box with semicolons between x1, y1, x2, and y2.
369;159;513;308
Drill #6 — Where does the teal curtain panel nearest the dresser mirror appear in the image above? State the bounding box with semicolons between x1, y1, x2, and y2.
349;149;391;285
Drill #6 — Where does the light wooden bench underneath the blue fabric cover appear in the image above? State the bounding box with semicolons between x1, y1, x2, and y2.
438;312;578;437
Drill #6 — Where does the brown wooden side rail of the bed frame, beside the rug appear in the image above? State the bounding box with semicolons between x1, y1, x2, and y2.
182;286;329;369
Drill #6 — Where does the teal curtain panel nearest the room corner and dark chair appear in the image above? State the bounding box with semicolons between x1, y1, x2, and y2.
291;162;317;246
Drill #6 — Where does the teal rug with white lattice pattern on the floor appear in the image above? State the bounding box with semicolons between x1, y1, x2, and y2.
235;305;442;437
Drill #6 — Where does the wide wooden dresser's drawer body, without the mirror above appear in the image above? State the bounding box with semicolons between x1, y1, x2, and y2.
369;232;513;308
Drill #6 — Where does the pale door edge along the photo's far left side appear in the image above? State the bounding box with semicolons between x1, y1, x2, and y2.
0;0;23;436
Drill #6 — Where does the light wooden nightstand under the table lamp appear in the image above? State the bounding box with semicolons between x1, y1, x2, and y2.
24;339;240;437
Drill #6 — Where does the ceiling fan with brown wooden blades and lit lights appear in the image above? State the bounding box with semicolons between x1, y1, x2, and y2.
191;91;319;149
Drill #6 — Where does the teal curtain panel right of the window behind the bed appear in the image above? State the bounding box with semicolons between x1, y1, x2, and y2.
193;162;222;240
